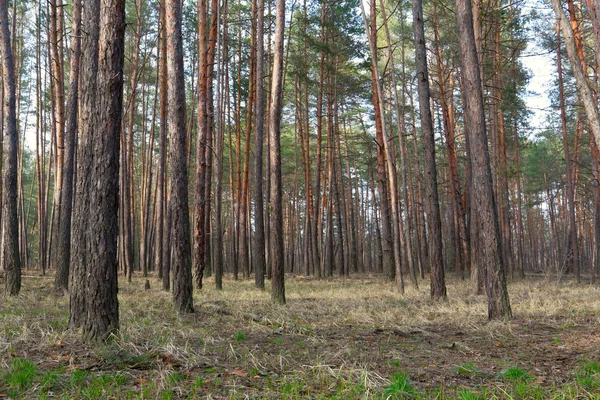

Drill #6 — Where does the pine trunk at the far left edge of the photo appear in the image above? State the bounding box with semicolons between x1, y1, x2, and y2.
0;0;21;296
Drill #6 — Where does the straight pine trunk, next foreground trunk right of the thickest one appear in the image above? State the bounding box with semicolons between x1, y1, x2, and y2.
166;0;194;313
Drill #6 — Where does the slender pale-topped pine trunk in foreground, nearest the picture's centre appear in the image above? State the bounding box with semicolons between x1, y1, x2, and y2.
269;0;285;304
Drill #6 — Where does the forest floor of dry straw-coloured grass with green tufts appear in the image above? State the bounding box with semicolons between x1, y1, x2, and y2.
0;274;600;399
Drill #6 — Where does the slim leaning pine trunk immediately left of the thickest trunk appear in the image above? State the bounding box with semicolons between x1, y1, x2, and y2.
54;0;81;291
